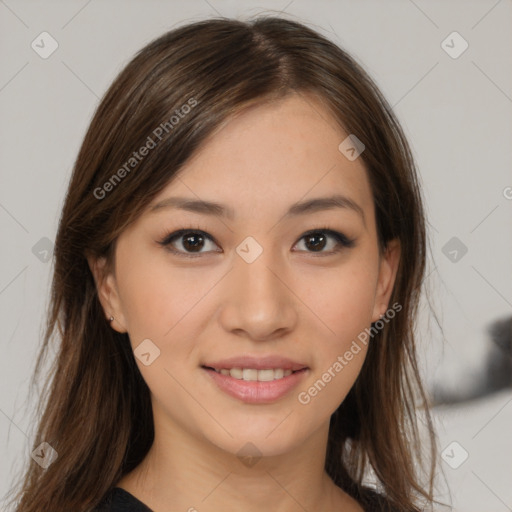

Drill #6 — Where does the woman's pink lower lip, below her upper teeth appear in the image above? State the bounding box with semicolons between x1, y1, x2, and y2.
202;366;309;404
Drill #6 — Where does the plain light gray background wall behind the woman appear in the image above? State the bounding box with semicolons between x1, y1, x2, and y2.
0;0;512;512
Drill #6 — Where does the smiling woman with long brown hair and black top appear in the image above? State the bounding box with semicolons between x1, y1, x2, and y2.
6;17;436;512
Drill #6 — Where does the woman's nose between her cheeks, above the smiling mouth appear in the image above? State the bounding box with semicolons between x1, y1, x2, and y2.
219;246;298;341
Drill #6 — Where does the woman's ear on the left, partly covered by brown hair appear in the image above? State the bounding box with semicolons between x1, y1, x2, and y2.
87;256;128;333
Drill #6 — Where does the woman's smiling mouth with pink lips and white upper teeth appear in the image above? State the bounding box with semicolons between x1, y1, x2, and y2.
201;358;309;404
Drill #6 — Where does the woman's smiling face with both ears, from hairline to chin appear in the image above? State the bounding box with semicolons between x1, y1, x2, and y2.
91;95;399;455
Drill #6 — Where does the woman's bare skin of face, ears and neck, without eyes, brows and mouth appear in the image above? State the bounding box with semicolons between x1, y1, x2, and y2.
89;94;399;512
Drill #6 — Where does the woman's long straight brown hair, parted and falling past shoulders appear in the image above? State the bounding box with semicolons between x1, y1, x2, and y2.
6;16;437;512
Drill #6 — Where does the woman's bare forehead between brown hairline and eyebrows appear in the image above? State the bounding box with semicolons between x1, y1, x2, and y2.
152;94;373;224
